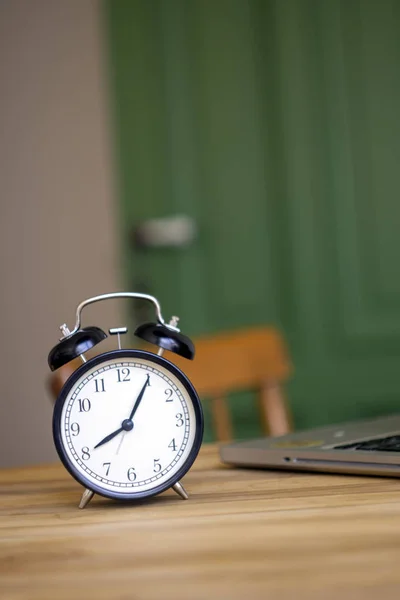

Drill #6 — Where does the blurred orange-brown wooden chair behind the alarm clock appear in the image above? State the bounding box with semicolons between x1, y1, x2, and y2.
49;327;292;442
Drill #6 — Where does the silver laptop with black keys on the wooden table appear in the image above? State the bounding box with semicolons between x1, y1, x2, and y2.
220;415;400;477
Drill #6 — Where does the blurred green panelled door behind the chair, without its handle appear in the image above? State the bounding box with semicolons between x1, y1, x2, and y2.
105;0;400;435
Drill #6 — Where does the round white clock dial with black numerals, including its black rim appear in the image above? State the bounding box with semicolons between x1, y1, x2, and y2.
53;350;203;498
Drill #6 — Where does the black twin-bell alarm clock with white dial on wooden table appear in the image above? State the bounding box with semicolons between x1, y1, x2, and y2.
48;292;203;508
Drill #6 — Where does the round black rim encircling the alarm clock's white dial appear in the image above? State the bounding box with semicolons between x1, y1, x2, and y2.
53;348;204;501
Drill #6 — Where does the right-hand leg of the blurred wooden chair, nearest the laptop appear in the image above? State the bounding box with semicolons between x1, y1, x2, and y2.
259;381;292;436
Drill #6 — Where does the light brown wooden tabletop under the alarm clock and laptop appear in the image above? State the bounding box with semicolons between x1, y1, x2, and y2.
0;446;400;600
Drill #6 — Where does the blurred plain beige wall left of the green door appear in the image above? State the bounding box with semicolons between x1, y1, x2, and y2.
0;0;121;466
